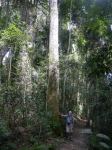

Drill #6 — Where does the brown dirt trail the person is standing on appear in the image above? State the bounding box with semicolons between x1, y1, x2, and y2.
57;122;91;150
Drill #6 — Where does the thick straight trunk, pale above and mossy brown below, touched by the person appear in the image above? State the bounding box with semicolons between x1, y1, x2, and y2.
47;0;59;115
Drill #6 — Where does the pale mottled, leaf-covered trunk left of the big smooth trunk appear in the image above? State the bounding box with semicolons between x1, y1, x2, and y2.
18;4;35;125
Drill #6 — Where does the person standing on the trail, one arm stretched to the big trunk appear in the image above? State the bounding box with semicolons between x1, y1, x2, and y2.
61;111;75;140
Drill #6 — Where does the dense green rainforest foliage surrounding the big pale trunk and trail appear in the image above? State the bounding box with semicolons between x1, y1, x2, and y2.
0;0;112;150
